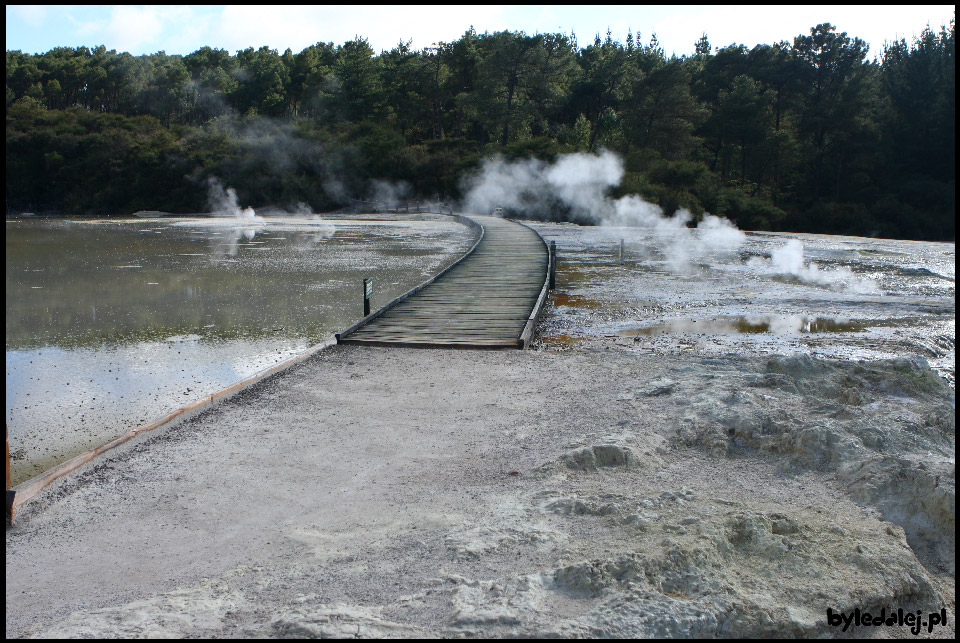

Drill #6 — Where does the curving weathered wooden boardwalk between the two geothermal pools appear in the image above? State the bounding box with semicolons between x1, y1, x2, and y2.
337;216;550;348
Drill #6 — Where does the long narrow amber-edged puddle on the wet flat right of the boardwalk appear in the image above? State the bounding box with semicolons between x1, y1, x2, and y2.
618;316;880;337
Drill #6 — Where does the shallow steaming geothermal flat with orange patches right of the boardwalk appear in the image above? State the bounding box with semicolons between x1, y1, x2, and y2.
533;223;956;385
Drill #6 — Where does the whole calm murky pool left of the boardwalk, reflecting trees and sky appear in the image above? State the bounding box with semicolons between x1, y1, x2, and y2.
6;214;473;484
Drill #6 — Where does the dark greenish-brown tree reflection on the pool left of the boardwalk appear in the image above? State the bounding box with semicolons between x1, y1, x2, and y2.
6;218;463;349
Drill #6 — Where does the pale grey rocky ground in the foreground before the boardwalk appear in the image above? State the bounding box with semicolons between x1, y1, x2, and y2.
6;226;955;638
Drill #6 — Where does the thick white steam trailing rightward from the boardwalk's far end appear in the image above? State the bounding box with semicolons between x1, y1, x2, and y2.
463;150;876;292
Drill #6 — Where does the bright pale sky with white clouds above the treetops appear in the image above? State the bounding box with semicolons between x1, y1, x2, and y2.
6;5;956;59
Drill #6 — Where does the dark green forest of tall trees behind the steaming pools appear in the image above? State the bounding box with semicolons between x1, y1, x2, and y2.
6;20;956;241
